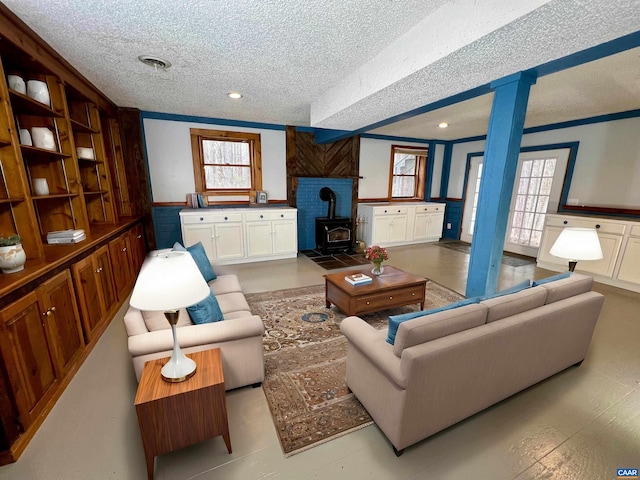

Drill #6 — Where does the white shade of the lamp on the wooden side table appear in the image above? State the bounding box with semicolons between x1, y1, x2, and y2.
129;251;211;311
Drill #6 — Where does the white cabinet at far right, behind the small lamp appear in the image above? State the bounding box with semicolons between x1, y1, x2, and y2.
537;214;640;291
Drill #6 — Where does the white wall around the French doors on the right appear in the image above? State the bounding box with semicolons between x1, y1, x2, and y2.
447;118;640;209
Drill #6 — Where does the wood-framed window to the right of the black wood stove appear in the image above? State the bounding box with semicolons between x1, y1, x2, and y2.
389;145;428;200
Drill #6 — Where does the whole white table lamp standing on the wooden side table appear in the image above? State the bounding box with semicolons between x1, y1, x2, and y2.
129;251;211;382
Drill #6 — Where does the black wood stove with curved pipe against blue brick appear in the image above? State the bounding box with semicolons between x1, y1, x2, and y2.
316;187;353;255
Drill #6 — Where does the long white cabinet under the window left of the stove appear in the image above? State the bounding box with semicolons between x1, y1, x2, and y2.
180;207;298;264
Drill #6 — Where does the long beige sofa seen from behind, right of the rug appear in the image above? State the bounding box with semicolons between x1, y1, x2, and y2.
340;273;604;455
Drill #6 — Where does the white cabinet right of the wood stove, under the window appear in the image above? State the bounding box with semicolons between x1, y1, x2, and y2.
358;202;445;247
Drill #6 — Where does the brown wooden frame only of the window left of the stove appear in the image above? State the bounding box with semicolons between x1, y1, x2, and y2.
189;128;262;202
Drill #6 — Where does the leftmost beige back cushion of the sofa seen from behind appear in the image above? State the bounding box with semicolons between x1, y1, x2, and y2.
393;303;487;357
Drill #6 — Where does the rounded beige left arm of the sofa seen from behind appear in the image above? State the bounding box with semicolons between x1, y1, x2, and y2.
340;317;408;389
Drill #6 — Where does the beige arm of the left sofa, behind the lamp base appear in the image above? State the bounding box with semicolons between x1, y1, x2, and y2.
125;314;264;357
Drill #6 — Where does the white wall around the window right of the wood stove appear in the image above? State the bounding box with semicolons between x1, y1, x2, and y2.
358;138;442;198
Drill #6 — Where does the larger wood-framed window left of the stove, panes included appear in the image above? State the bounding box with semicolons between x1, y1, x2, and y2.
190;128;262;199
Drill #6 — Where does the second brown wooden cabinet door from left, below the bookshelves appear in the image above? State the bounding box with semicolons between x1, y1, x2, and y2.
37;270;85;378
